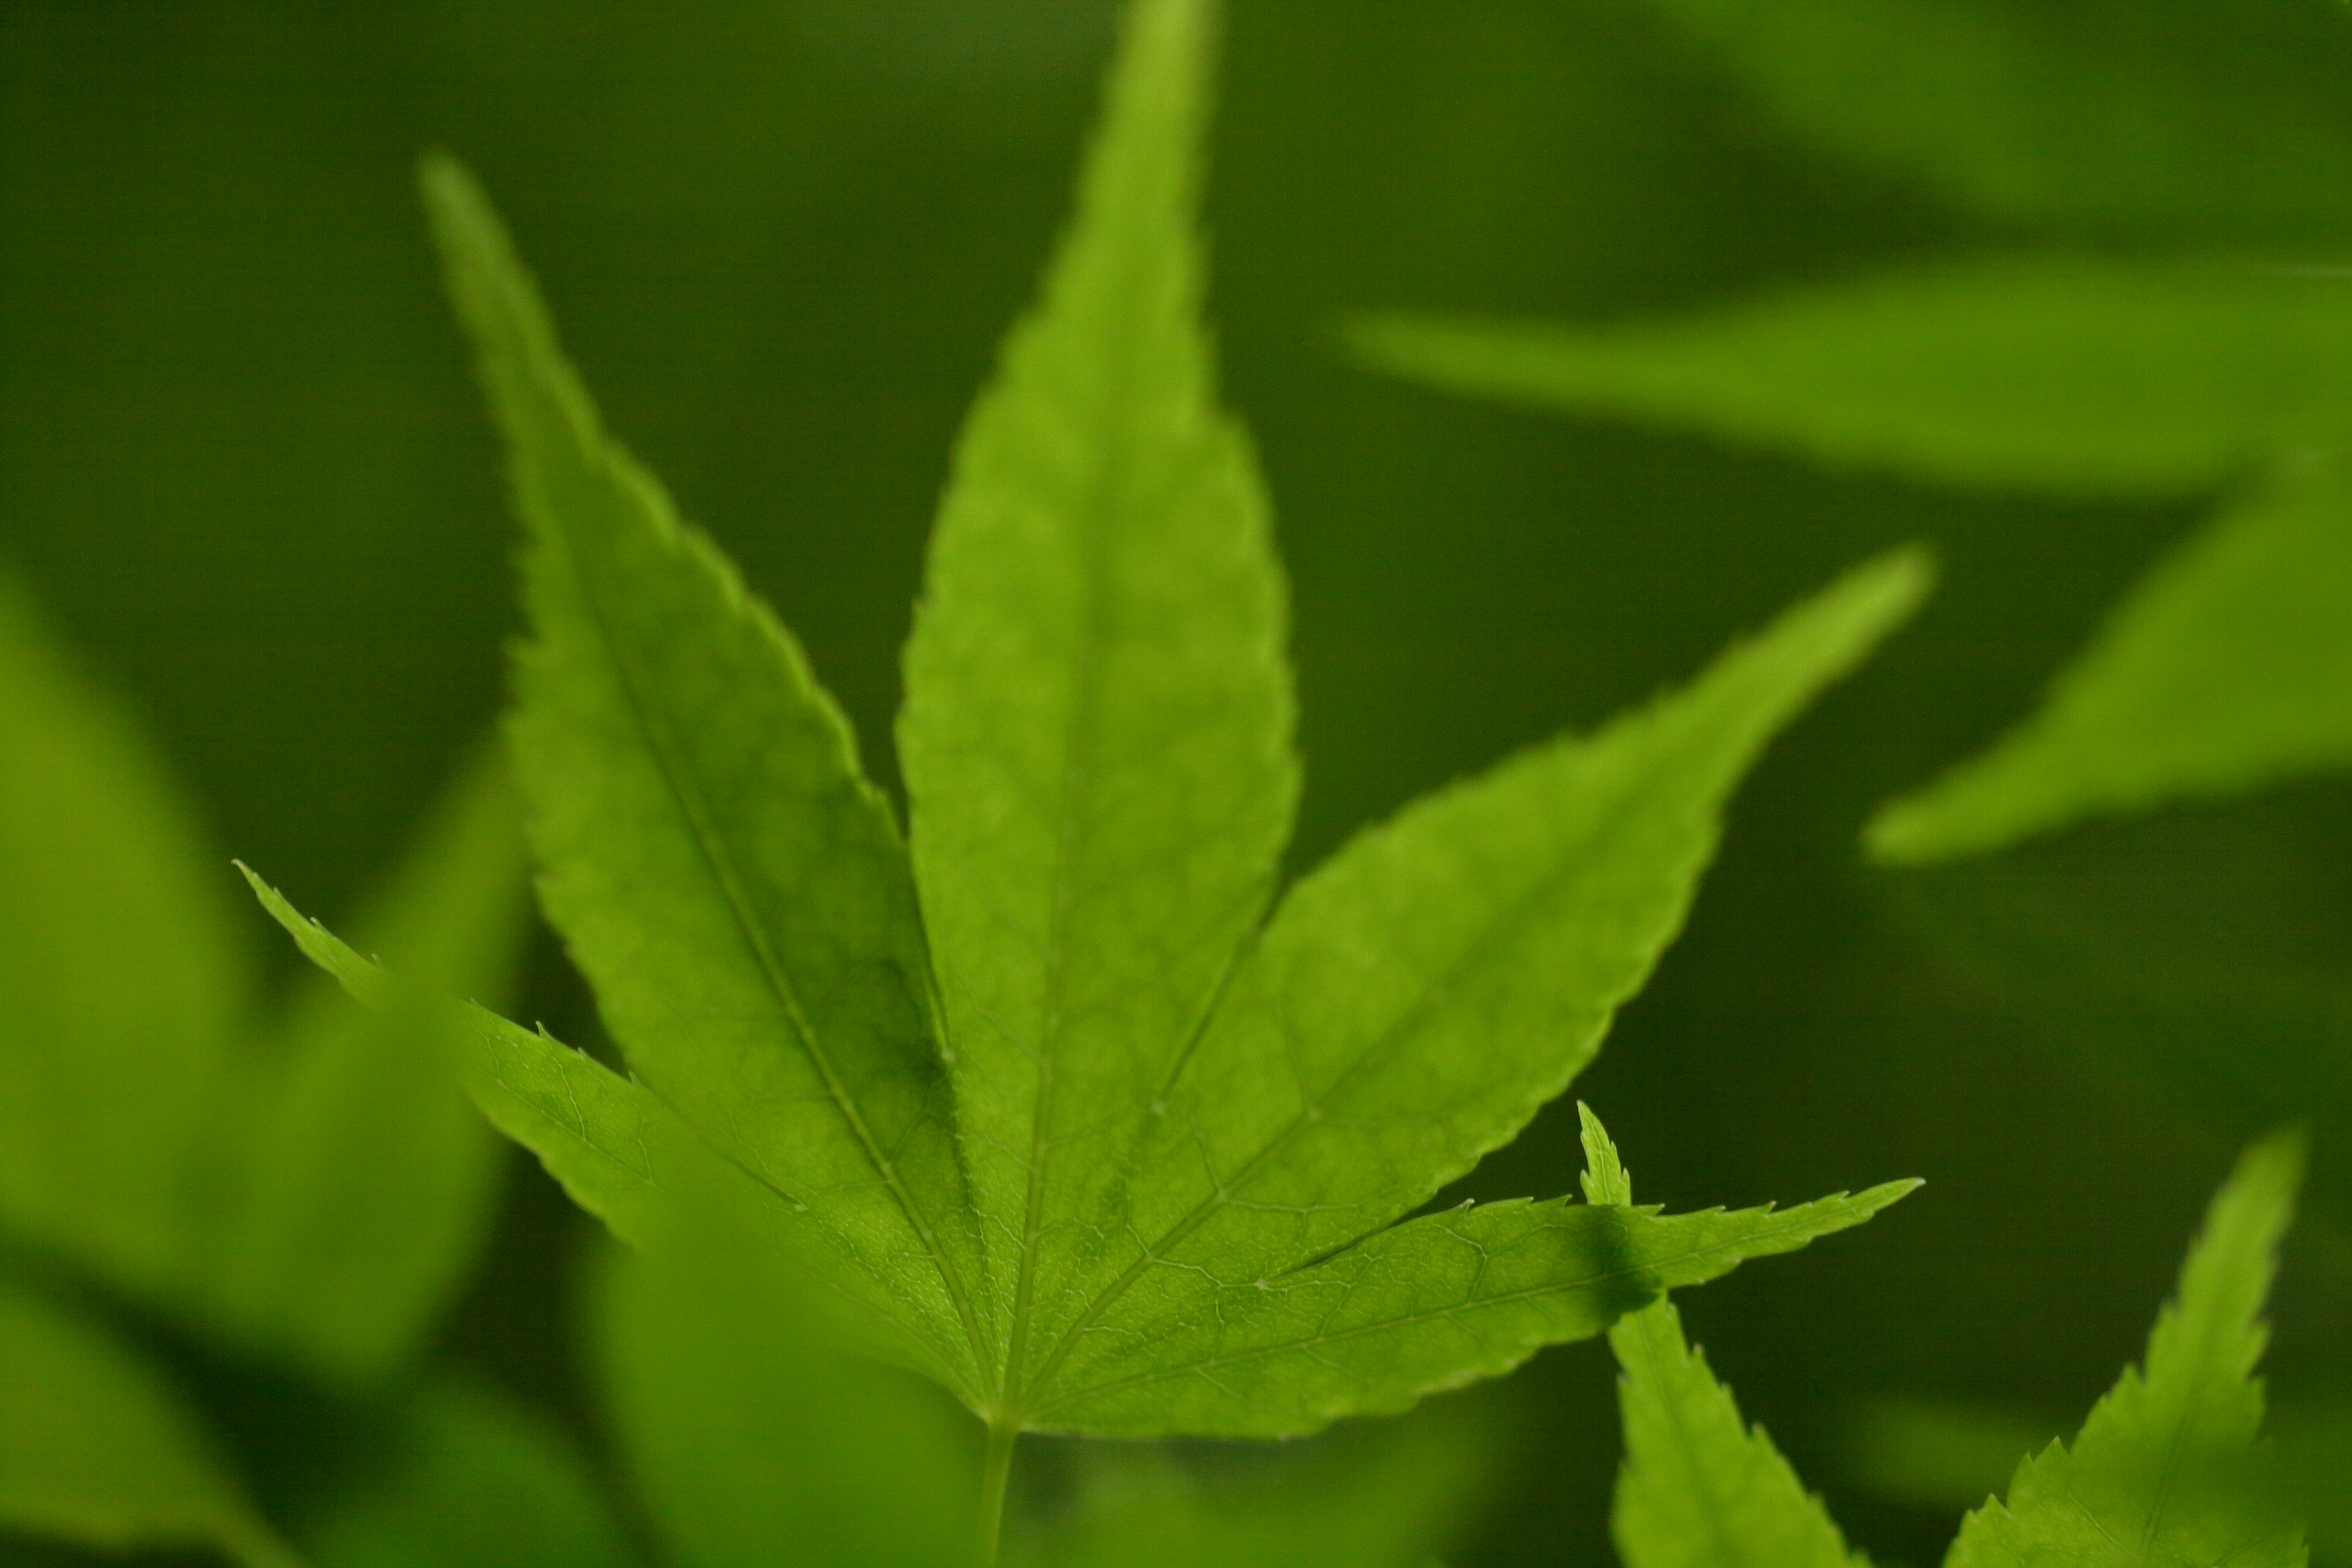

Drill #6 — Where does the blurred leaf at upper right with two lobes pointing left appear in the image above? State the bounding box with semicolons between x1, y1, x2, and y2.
1357;261;2352;861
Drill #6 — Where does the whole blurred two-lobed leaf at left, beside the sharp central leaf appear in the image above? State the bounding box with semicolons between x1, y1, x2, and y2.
0;576;522;1382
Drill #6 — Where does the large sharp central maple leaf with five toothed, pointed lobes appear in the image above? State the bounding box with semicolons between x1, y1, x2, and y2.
357;0;1926;1455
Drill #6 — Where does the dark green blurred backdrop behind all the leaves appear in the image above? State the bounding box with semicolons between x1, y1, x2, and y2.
0;0;2352;1566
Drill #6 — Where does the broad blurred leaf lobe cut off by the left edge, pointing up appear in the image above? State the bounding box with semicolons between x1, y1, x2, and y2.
0;578;247;1295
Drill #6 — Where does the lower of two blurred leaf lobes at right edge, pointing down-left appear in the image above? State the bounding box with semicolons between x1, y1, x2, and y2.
1868;458;2352;861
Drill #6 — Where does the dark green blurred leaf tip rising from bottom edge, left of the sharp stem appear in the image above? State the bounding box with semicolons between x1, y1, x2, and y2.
296;1375;638;1568
